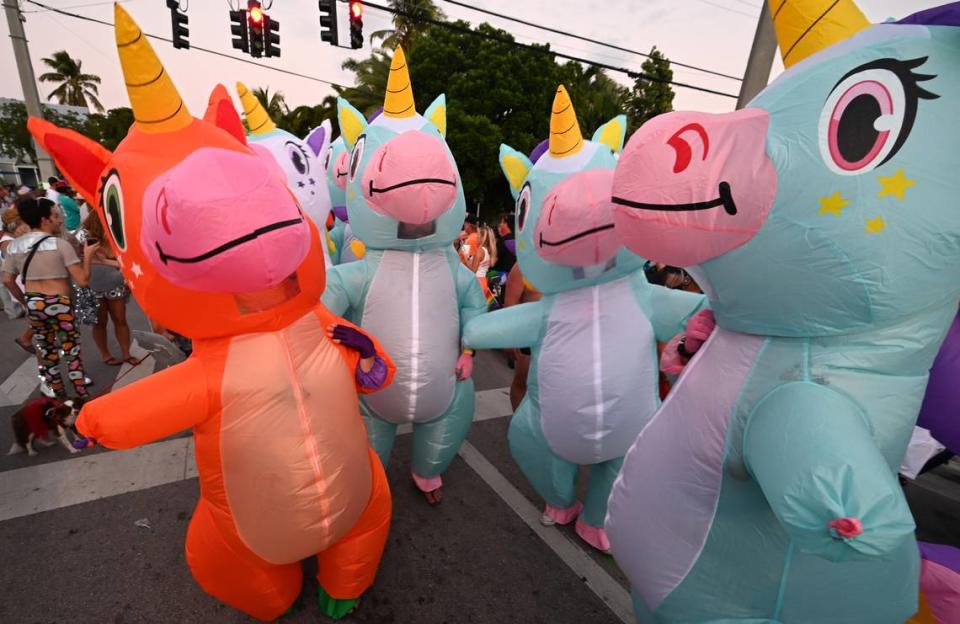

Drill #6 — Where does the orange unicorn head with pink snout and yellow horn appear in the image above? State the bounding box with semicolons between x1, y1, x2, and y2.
29;5;324;338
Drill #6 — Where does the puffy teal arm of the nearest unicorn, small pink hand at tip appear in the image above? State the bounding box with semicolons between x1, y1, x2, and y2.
743;381;915;561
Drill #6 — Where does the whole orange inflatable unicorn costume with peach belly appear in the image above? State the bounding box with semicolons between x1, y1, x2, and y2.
29;6;393;620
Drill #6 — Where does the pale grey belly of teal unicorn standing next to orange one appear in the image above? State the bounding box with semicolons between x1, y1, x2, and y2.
360;250;460;423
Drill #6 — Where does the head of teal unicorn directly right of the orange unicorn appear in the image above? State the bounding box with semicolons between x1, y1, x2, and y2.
337;47;466;251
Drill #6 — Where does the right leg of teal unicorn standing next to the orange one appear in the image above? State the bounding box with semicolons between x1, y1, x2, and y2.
412;379;475;482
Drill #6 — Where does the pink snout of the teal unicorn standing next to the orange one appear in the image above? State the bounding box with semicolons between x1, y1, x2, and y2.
361;131;457;225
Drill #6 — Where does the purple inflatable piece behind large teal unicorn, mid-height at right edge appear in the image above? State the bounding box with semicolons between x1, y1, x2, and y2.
917;315;960;453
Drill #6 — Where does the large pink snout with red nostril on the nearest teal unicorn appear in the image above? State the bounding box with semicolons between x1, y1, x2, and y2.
613;109;777;266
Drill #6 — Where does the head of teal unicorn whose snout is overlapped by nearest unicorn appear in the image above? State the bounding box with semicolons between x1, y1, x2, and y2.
500;85;643;293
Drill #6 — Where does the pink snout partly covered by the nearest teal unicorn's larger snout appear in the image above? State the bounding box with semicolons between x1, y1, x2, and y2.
533;169;620;267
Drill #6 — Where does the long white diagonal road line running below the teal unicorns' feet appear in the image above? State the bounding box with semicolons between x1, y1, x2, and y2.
460;442;635;624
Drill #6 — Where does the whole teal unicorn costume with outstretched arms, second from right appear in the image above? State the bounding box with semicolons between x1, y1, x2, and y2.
464;86;704;551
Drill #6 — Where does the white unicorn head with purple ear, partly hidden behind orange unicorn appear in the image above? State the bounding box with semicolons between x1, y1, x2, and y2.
237;82;331;232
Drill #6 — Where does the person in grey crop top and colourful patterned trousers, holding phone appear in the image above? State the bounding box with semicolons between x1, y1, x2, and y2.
0;197;100;399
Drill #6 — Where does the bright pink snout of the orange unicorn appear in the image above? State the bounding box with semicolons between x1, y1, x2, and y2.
140;148;310;292
